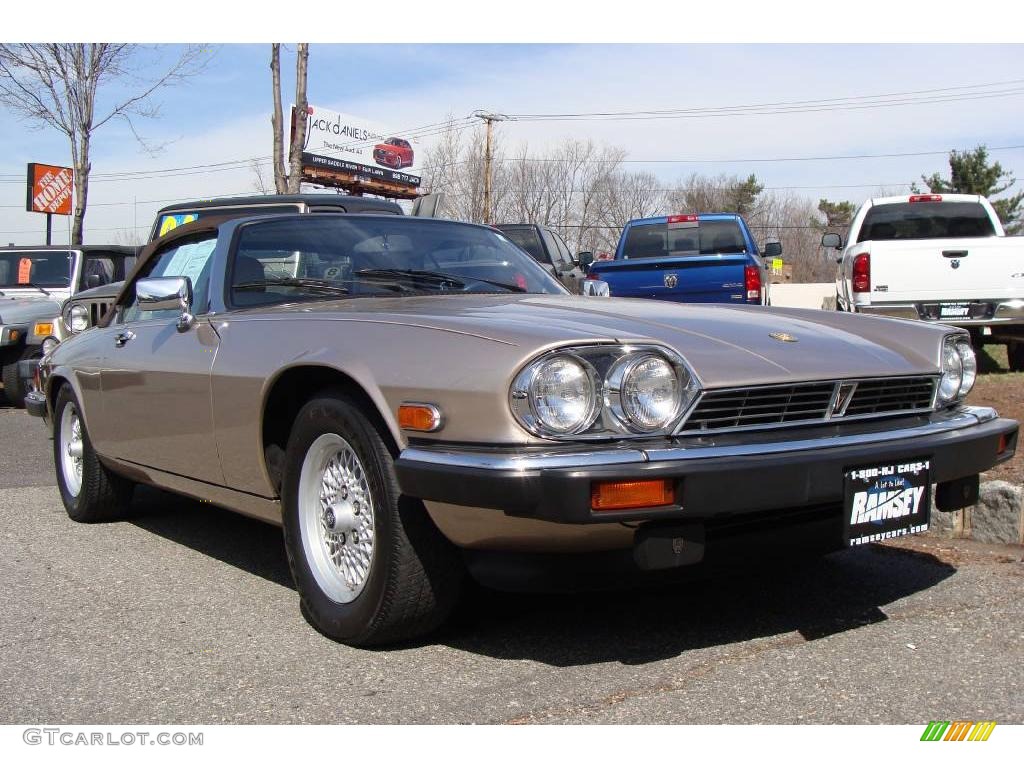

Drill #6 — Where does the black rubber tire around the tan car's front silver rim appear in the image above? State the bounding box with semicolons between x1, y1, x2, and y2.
282;391;464;646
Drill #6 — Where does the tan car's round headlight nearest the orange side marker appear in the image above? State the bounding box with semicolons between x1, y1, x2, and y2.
513;354;597;434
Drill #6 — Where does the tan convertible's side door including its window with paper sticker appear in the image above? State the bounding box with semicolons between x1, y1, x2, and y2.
90;232;223;483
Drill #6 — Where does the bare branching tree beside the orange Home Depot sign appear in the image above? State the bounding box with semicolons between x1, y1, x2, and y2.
0;43;210;245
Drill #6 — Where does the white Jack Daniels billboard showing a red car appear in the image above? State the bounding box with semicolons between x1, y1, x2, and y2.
292;105;422;187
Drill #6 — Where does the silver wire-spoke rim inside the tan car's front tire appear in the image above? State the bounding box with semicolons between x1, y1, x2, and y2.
298;433;376;603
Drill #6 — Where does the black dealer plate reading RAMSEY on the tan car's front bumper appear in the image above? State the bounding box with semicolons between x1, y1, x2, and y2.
844;459;932;547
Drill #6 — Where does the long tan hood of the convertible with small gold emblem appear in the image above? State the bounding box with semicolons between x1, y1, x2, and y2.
245;295;942;387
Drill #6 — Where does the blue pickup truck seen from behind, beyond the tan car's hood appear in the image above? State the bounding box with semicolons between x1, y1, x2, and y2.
587;213;782;304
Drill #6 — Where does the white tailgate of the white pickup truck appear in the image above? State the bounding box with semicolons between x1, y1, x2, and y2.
868;238;1024;303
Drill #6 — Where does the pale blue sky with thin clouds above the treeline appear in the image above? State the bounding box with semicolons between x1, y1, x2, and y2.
0;44;1024;243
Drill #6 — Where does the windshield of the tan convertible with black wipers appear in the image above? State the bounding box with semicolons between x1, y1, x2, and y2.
229;216;565;306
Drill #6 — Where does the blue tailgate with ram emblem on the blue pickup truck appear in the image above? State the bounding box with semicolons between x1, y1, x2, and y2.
590;254;750;303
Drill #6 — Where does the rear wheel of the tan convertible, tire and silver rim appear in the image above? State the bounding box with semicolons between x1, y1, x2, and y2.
53;384;134;522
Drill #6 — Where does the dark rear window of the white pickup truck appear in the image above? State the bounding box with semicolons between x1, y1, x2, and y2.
857;203;995;243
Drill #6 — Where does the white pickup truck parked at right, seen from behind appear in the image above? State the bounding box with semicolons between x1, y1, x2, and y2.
821;195;1024;371
